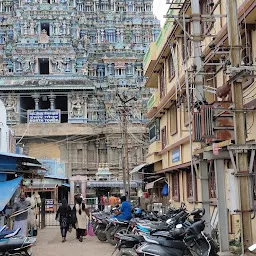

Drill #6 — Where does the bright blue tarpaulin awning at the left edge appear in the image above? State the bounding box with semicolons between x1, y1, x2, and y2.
0;177;22;211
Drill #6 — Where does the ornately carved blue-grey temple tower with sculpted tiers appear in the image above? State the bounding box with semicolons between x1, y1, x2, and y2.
0;0;160;200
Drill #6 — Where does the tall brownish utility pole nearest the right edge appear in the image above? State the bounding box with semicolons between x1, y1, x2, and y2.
226;0;252;254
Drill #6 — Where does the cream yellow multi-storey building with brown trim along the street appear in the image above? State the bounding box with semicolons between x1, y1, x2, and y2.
144;0;256;249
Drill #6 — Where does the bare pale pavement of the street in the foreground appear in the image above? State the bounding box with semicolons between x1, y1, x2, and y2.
33;227;114;256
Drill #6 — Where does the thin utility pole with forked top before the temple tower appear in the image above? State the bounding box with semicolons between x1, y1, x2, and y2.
117;93;137;200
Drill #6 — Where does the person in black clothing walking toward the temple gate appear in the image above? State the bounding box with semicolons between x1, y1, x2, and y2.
56;198;71;242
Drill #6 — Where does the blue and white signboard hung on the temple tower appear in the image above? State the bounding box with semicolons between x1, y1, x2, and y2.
28;109;61;123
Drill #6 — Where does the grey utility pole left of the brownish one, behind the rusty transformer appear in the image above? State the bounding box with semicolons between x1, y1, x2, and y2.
191;0;211;234
